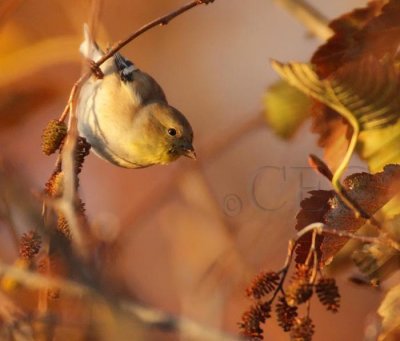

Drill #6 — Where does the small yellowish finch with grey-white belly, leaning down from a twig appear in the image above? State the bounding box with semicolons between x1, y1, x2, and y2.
77;25;196;168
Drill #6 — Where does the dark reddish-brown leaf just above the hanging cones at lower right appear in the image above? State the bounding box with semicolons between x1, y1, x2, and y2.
296;165;400;264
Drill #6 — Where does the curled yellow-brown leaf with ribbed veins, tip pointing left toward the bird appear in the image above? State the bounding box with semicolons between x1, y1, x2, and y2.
272;56;400;130
